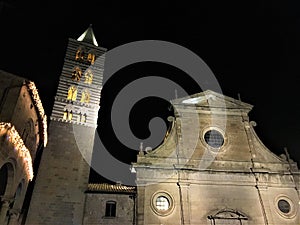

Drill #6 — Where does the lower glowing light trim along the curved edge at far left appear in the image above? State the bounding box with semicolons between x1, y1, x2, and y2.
0;122;33;181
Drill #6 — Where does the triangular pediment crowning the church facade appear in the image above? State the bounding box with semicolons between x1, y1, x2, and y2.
171;90;253;111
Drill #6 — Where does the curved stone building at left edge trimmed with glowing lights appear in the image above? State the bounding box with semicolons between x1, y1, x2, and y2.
0;70;47;225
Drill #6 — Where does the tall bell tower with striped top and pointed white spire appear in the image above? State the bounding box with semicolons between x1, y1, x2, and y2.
26;25;106;225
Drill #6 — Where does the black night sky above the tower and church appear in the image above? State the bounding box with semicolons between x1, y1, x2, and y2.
0;0;300;174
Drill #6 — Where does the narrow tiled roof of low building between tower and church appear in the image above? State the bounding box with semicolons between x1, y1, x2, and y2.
88;183;136;194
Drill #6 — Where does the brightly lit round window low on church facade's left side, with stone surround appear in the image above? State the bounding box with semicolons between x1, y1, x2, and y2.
151;192;174;216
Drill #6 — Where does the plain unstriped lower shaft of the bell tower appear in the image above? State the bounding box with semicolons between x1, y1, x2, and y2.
26;121;95;225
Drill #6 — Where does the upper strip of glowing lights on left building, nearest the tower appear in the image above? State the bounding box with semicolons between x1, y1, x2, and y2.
27;81;48;147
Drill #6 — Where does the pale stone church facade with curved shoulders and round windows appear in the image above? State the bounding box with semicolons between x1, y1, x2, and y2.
133;91;300;225
